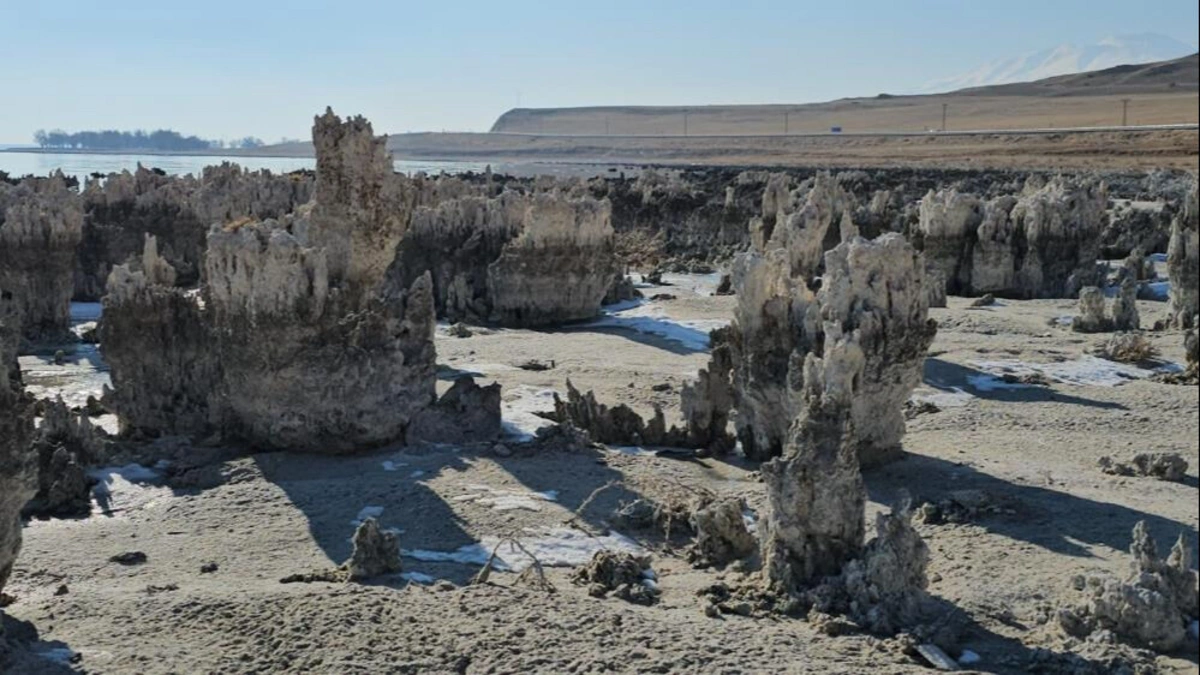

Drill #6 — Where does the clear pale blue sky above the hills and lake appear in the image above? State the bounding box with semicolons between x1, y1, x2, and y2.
0;0;1200;143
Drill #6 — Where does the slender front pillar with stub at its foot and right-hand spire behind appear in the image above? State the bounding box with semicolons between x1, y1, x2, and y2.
762;234;935;633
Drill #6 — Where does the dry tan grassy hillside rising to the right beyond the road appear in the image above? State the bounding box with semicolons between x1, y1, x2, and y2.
492;55;1200;136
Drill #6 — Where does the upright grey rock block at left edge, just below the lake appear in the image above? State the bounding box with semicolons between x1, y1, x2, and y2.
0;173;83;341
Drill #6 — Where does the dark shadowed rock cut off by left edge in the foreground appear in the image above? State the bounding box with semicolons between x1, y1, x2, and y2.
0;293;37;600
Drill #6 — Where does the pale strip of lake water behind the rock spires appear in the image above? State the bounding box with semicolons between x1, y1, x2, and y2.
0;153;486;184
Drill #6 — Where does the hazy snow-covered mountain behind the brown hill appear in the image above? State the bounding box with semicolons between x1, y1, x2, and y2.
922;34;1196;94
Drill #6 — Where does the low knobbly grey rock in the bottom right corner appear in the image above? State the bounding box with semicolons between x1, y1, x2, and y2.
1058;521;1198;652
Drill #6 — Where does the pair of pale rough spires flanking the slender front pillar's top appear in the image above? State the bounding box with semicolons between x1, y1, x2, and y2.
730;234;936;464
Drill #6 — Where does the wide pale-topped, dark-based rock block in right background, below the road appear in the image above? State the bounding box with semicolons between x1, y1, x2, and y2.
917;178;1108;299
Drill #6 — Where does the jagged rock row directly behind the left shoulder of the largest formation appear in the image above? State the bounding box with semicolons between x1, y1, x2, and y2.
74;162;313;301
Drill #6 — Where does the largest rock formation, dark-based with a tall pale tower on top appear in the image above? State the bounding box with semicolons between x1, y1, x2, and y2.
101;112;499;453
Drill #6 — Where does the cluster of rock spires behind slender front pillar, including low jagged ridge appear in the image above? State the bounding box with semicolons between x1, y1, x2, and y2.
553;174;936;465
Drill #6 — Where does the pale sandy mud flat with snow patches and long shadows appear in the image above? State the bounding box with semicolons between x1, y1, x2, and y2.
5;270;1200;673
